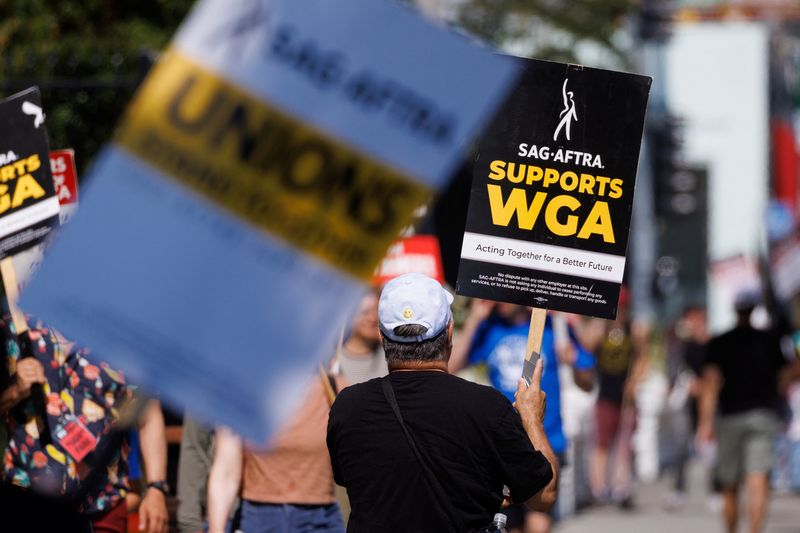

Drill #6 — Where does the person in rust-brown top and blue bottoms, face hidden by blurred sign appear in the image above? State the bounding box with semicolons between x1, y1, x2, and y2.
208;378;344;533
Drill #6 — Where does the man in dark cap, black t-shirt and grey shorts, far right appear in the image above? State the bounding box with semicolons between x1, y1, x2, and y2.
697;292;787;532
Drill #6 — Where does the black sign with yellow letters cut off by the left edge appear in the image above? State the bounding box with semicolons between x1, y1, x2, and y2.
0;87;59;258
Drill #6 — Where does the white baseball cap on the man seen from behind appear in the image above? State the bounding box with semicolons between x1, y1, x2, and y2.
378;274;453;342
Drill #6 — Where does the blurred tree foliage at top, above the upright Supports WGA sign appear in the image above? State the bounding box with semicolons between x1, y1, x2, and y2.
456;0;638;62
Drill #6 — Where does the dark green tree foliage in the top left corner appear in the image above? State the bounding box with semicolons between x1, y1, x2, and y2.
0;0;194;174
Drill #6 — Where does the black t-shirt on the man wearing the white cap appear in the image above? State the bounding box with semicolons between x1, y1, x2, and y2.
328;371;553;533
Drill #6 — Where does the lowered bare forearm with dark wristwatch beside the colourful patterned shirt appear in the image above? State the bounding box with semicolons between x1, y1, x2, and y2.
139;400;169;533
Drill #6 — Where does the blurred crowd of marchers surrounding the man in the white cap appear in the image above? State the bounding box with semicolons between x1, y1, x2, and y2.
2;278;800;533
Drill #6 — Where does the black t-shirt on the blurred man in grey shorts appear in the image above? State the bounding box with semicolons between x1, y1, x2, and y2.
706;327;787;415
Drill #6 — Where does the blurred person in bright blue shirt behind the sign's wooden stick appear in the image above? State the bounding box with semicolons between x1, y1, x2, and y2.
449;300;595;533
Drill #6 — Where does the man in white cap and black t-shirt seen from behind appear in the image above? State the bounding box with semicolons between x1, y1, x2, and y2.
328;274;558;533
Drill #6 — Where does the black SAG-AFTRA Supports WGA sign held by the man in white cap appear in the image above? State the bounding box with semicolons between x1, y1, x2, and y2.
457;60;652;318
